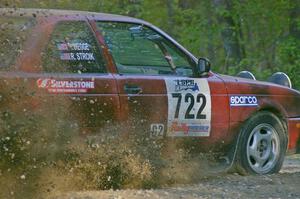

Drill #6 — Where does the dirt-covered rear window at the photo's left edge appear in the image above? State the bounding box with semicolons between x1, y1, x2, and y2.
0;17;36;71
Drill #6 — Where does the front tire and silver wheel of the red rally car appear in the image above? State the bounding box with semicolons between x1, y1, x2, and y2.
236;111;288;175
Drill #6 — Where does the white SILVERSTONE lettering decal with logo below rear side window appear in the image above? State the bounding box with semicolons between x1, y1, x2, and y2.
37;78;95;93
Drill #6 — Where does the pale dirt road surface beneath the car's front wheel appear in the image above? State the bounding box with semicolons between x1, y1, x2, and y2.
57;155;300;199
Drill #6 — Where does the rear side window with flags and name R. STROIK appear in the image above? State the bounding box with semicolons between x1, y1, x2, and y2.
42;21;105;73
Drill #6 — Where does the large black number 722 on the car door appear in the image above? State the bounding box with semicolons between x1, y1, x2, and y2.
172;93;206;119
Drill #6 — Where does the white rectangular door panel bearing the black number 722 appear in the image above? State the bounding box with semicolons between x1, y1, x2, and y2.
165;78;211;137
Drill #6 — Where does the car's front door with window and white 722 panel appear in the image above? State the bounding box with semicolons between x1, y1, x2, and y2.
97;22;219;145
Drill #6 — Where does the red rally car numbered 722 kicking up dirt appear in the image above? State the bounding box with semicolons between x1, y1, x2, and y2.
0;8;300;174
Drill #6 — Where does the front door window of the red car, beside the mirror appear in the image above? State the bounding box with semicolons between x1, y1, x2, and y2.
97;22;193;76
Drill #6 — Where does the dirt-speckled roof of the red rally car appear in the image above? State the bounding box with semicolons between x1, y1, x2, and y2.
0;8;149;24
